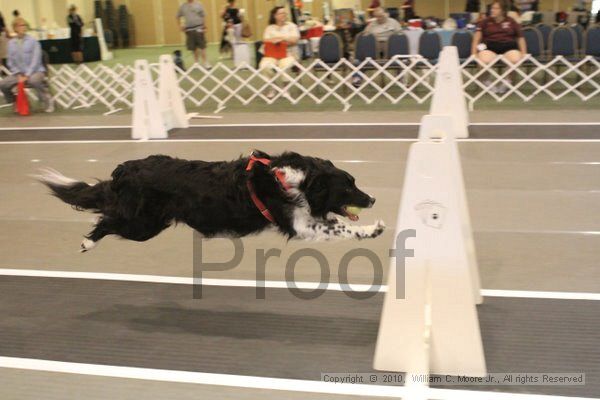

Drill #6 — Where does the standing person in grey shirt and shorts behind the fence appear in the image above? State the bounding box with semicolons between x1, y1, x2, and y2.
177;0;210;68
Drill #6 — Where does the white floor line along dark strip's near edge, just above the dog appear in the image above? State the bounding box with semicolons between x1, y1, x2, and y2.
0;137;600;145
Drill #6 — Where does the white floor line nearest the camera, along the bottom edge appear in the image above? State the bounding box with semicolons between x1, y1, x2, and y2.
0;357;592;400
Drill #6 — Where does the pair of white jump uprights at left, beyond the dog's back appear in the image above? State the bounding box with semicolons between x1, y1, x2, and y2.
131;55;190;139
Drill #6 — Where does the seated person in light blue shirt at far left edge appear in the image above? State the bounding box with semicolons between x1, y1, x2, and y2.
0;18;54;112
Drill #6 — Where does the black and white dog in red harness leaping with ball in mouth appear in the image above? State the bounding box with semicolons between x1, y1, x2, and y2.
38;151;385;251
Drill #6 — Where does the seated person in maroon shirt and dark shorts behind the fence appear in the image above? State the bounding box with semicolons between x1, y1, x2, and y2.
471;1;527;64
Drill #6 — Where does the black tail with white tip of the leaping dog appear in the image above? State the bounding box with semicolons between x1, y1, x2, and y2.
34;168;106;212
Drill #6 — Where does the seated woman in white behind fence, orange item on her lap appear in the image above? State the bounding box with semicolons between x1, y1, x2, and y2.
258;7;300;97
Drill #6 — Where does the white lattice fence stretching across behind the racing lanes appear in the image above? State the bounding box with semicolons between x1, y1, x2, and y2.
0;56;600;114
